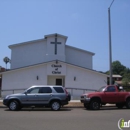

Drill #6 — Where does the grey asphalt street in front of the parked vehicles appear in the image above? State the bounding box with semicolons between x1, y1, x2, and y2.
0;107;130;130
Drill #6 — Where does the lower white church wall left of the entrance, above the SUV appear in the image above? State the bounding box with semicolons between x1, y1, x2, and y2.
2;64;47;96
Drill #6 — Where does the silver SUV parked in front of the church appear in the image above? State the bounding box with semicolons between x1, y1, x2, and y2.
3;85;70;111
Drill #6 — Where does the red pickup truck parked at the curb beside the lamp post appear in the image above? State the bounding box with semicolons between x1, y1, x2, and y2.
80;85;130;110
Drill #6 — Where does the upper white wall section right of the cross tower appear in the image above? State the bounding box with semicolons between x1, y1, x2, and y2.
66;46;93;69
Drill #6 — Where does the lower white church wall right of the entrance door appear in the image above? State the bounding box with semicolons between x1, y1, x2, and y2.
65;65;107;99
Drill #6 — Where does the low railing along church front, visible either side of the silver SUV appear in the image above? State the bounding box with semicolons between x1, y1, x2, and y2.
0;87;96;100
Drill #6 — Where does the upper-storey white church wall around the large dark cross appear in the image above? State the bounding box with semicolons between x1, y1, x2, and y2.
9;35;94;69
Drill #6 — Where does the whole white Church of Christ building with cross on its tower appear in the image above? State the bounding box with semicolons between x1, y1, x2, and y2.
1;34;107;97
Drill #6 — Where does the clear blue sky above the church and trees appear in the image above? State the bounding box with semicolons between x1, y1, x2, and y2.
0;0;130;71
